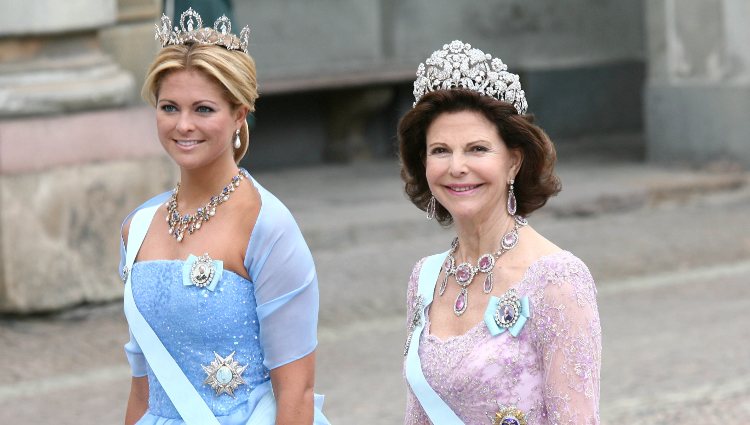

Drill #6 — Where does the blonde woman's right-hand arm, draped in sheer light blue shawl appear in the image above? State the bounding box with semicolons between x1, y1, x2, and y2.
250;192;318;425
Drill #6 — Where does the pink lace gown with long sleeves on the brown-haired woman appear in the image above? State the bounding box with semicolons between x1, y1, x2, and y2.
405;251;602;425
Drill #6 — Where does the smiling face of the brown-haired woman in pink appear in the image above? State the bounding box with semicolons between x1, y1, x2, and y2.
425;111;521;224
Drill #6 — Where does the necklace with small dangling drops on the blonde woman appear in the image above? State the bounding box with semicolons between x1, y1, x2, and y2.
166;168;250;242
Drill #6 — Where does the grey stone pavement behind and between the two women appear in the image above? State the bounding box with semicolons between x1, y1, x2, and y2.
0;137;750;425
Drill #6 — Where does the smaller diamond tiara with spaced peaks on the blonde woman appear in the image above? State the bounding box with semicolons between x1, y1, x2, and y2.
154;7;250;53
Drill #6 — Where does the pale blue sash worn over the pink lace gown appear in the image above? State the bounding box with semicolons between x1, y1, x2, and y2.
406;251;463;425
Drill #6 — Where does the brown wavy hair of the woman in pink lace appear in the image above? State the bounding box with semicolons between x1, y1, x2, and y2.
398;89;562;226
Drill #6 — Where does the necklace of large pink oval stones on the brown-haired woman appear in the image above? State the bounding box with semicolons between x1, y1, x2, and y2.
438;215;529;316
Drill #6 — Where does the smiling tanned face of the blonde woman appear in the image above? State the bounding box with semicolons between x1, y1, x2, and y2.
156;70;247;169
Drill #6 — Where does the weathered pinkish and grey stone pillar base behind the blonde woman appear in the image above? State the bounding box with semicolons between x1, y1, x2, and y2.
0;0;174;313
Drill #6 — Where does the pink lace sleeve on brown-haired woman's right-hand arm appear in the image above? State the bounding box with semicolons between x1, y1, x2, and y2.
532;258;602;425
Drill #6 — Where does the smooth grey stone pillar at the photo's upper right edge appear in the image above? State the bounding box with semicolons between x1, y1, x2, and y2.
645;0;750;166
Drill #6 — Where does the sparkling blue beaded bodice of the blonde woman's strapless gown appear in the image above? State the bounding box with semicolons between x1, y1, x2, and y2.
131;260;270;418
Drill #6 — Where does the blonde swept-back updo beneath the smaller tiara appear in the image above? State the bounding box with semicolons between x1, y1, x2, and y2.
141;29;258;164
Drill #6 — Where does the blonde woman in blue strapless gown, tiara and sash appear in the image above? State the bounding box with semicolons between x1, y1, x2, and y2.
121;9;327;425
